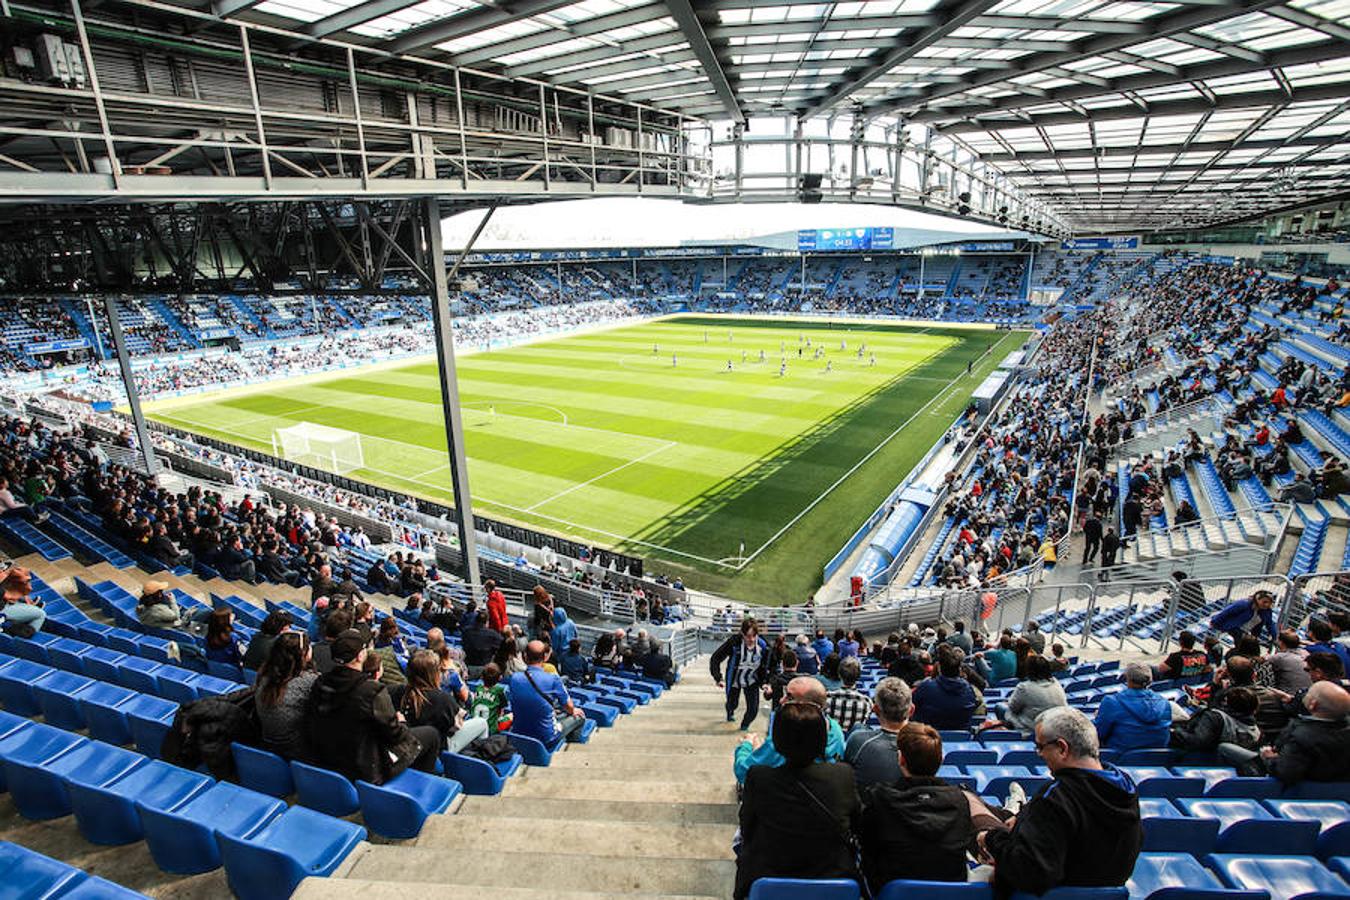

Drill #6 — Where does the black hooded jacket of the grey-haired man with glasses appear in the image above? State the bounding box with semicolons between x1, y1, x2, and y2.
986;766;1143;896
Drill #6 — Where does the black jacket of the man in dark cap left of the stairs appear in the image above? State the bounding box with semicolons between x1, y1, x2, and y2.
305;665;421;784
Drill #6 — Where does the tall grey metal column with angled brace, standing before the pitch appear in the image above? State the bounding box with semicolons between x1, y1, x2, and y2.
421;197;497;595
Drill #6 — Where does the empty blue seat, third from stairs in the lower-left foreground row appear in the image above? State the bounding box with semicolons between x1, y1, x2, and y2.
66;760;215;845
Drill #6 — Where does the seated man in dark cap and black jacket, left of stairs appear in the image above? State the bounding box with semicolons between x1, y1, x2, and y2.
305;629;441;784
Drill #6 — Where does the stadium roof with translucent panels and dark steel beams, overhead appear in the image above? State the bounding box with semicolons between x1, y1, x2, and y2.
181;0;1350;228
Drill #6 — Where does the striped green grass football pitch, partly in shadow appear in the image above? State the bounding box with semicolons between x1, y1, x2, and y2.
149;317;1025;603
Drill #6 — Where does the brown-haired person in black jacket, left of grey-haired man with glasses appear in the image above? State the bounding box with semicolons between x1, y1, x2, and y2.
859;722;975;896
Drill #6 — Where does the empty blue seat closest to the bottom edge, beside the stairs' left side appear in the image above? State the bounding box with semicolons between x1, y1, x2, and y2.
217;807;366;900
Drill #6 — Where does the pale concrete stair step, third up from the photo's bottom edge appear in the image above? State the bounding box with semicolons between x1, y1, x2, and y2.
416;812;734;860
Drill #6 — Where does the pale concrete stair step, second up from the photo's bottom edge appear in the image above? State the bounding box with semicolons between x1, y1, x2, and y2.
346;847;736;897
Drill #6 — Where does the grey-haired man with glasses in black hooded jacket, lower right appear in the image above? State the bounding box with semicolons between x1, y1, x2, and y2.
973;712;1146;895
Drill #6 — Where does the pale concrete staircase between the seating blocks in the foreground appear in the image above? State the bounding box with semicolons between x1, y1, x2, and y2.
294;660;739;900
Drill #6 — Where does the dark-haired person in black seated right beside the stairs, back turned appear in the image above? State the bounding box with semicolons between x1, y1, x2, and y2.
734;699;860;899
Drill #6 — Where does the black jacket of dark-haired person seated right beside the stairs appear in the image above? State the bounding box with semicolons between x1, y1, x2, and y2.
736;761;860;899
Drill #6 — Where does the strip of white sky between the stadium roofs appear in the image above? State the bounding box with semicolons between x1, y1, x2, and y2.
441;197;1000;251
